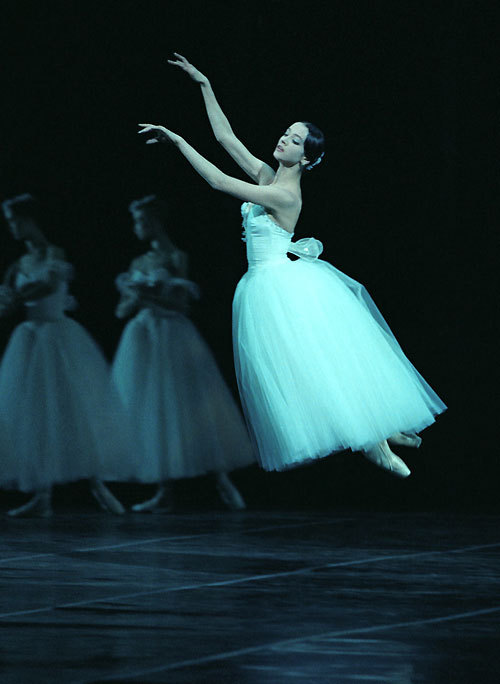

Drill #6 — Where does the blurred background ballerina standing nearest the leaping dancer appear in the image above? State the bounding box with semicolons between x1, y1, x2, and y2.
112;195;256;512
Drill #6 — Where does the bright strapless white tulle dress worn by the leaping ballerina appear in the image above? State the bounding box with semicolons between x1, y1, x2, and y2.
233;202;446;470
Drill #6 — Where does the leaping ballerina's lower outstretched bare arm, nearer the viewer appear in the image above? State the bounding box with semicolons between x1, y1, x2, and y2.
139;124;296;211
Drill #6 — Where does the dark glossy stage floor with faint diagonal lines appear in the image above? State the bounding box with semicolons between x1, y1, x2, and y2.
0;511;500;684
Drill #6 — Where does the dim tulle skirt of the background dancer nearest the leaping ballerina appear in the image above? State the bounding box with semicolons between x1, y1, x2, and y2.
113;308;256;482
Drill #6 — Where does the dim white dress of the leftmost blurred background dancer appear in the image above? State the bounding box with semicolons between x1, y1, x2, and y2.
0;247;134;492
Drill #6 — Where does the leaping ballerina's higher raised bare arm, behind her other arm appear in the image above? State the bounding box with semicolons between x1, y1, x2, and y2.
168;52;274;185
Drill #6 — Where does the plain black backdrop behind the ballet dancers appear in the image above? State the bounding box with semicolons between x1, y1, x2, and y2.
0;0;500;509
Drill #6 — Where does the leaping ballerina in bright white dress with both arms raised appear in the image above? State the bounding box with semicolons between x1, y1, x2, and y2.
139;53;446;477
